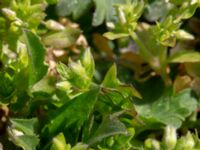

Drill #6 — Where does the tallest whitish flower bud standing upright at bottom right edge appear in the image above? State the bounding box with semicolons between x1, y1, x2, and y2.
163;126;177;150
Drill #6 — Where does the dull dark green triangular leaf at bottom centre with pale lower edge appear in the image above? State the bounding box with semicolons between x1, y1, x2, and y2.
88;115;128;145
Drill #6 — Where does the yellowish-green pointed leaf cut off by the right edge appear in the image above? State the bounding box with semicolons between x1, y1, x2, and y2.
168;51;200;63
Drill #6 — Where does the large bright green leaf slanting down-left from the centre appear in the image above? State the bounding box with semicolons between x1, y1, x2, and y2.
42;87;99;138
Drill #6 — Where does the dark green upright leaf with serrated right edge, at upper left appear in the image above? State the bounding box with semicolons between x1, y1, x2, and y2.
24;30;47;86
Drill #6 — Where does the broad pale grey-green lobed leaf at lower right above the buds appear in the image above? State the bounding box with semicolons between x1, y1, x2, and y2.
135;89;197;128
